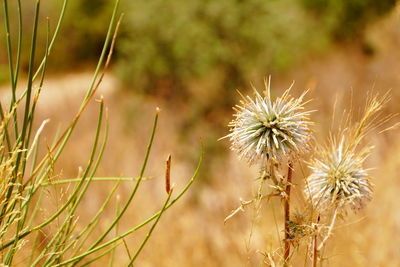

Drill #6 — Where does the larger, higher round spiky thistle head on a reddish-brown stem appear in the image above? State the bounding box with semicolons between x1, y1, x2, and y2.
226;79;312;164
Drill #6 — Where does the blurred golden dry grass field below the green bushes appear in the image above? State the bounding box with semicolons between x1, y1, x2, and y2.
0;1;400;267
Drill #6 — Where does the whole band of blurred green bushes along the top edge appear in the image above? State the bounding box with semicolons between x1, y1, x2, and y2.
0;0;395;92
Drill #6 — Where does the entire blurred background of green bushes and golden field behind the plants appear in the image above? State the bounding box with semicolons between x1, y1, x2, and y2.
0;0;400;266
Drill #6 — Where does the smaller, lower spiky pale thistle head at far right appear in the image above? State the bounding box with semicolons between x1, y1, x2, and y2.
304;138;372;215
